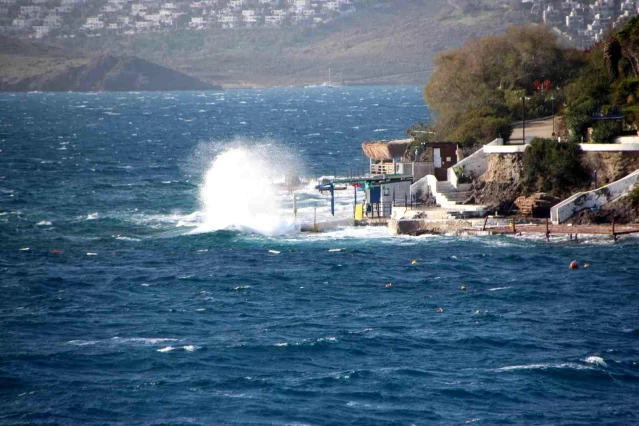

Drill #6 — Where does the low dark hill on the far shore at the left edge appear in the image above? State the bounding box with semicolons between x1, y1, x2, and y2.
0;37;220;92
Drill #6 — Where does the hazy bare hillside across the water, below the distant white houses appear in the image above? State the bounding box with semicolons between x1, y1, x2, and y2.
51;0;529;86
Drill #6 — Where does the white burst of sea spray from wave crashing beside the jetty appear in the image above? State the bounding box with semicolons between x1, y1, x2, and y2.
195;146;300;235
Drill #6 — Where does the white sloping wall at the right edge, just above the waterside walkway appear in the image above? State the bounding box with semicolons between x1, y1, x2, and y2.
550;170;639;225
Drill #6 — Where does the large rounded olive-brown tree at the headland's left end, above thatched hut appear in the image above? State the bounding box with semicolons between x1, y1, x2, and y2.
424;25;584;148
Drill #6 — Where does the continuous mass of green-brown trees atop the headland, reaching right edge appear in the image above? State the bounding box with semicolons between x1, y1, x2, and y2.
424;17;639;149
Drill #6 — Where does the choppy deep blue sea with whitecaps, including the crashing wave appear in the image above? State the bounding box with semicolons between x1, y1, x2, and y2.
0;87;639;425
